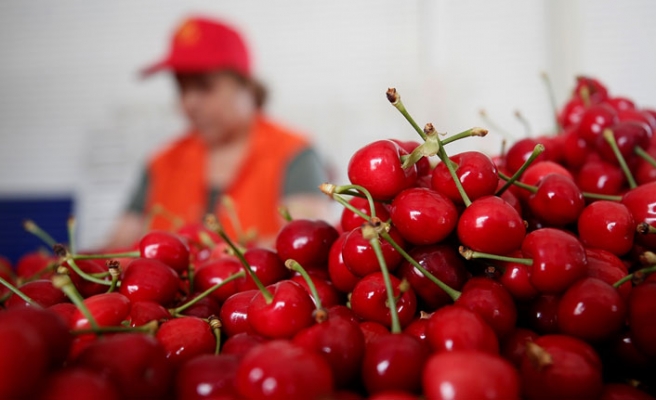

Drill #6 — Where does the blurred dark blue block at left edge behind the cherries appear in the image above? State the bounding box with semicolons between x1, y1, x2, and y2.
0;196;73;266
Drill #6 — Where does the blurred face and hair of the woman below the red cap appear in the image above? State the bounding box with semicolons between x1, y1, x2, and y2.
175;71;256;144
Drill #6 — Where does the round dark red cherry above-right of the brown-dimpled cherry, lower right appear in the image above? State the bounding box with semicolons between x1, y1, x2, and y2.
558;278;626;342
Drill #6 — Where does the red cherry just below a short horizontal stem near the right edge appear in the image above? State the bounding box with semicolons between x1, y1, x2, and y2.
578;200;636;256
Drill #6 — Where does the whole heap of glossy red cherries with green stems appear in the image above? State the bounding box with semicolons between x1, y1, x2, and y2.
0;78;656;400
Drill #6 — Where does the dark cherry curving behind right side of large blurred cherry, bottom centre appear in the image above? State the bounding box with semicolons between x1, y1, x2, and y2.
293;317;365;388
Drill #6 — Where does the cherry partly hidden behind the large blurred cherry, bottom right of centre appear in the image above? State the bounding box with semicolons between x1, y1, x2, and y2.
426;306;499;354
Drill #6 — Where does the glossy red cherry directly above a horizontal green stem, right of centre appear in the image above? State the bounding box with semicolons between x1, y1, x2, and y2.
457;196;526;255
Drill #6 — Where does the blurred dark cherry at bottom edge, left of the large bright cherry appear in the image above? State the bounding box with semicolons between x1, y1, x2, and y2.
175;354;239;400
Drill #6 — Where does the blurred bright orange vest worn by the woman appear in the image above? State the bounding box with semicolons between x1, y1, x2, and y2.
146;116;309;238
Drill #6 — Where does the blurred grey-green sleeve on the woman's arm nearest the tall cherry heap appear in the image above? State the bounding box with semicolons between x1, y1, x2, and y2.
283;148;328;196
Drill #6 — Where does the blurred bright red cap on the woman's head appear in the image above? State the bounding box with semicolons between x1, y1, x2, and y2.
142;18;251;77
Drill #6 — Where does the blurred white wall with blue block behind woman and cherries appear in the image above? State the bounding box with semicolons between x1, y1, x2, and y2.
0;0;656;260
